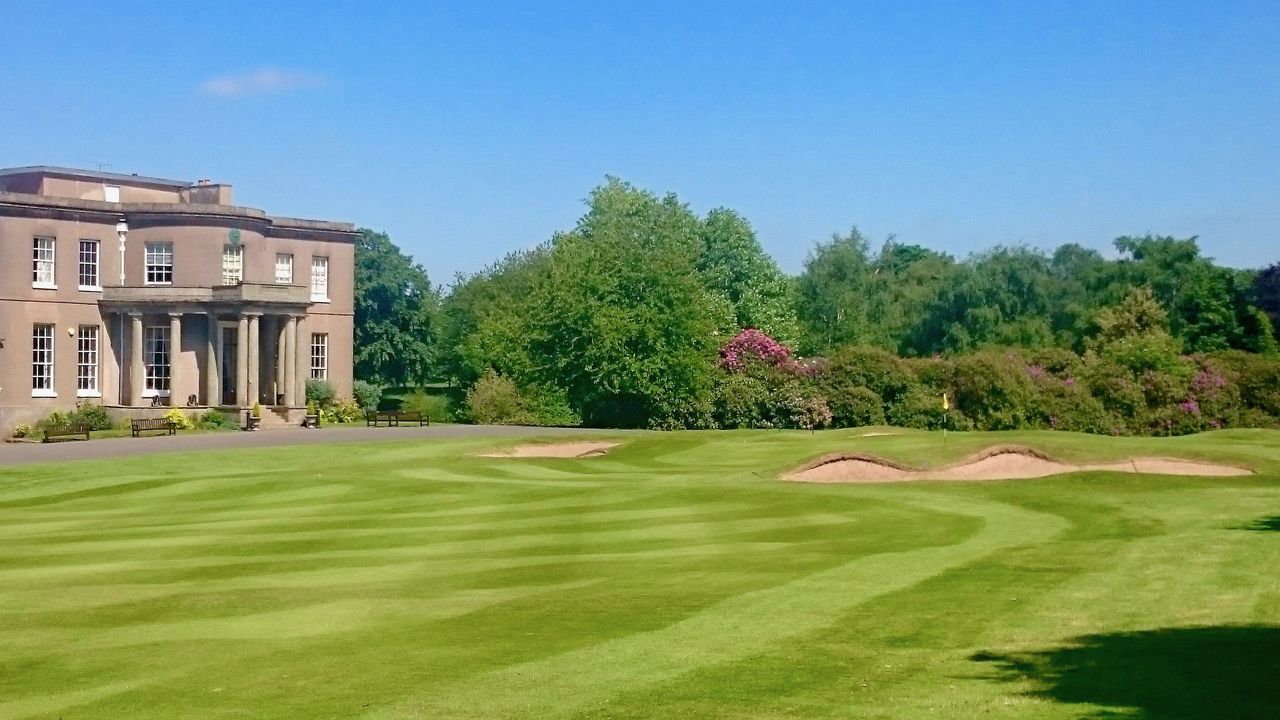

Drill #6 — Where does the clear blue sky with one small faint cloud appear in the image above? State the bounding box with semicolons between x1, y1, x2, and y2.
0;0;1280;283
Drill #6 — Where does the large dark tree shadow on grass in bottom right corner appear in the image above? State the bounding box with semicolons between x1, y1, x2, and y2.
970;625;1280;720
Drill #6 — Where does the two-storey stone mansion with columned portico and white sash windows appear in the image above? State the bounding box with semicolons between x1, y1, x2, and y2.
0;167;357;434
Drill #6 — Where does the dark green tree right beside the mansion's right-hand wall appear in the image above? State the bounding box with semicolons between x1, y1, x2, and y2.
355;228;440;386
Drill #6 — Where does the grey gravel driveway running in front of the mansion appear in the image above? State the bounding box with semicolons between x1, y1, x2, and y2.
0;425;594;468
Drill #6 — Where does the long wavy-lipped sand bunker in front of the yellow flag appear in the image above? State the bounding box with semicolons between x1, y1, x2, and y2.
785;447;1253;483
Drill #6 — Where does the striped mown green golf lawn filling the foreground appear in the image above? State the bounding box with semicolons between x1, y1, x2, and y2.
0;430;1280;719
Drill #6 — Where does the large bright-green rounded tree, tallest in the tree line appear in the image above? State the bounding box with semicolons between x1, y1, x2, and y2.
530;178;735;427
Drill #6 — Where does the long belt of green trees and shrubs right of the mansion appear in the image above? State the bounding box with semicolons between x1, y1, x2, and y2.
356;178;1280;432
